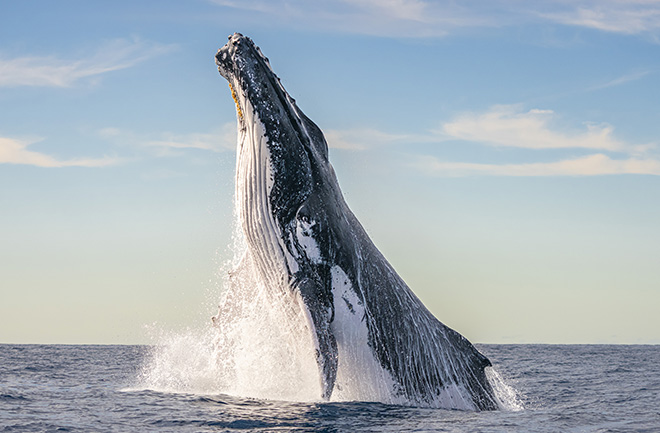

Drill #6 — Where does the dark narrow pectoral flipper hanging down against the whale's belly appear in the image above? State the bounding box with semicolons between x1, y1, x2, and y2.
296;278;338;400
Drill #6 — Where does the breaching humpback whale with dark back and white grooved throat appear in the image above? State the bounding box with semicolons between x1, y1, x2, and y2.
215;33;498;410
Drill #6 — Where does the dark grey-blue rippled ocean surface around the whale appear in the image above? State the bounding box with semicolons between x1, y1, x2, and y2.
0;344;660;433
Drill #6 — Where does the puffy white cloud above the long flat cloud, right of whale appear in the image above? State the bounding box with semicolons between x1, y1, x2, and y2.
440;105;633;152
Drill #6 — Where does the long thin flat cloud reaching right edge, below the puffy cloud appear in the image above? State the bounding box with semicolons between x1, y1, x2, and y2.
414;153;660;177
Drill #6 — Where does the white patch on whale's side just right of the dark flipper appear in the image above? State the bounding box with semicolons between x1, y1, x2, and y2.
330;266;405;404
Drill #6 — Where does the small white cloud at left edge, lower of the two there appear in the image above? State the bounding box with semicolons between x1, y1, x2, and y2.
0;137;121;167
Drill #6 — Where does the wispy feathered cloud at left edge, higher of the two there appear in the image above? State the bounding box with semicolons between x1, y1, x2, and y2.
0;39;173;87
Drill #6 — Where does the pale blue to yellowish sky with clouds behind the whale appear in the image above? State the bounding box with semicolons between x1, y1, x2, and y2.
0;0;660;344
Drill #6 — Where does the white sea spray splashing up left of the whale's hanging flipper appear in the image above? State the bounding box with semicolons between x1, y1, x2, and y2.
136;235;320;401
